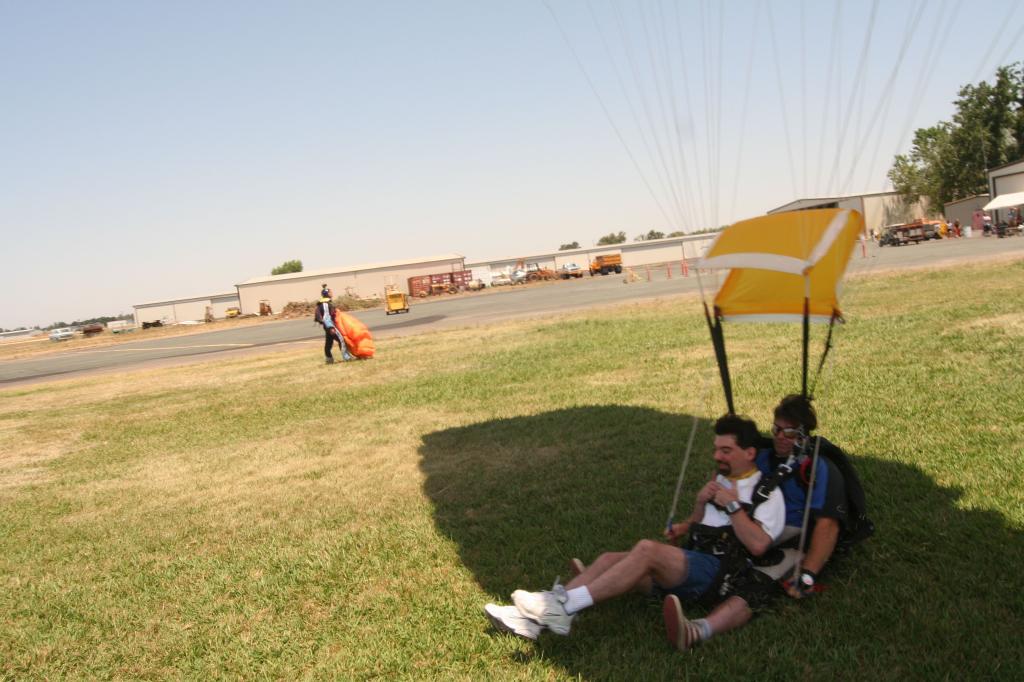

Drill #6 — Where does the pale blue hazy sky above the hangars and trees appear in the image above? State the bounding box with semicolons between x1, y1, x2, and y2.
0;0;1024;328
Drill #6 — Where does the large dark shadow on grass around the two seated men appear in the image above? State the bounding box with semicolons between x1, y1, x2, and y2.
420;406;1024;679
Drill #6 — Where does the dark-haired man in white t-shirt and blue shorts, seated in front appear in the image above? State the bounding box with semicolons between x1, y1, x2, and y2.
484;415;785;650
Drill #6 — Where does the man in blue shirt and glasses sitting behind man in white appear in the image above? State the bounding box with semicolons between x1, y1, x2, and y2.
756;394;849;598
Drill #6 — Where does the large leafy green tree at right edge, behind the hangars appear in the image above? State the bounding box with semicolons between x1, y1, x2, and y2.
889;63;1024;210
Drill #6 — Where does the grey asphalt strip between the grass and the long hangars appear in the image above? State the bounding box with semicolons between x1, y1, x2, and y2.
8;237;1024;386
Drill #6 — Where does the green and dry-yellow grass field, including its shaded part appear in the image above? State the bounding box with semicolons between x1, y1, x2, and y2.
0;261;1024;680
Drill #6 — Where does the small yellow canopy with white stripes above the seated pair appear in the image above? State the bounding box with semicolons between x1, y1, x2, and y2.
698;209;864;323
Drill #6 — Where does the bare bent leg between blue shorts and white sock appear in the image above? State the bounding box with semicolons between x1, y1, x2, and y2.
573;540;687;603
